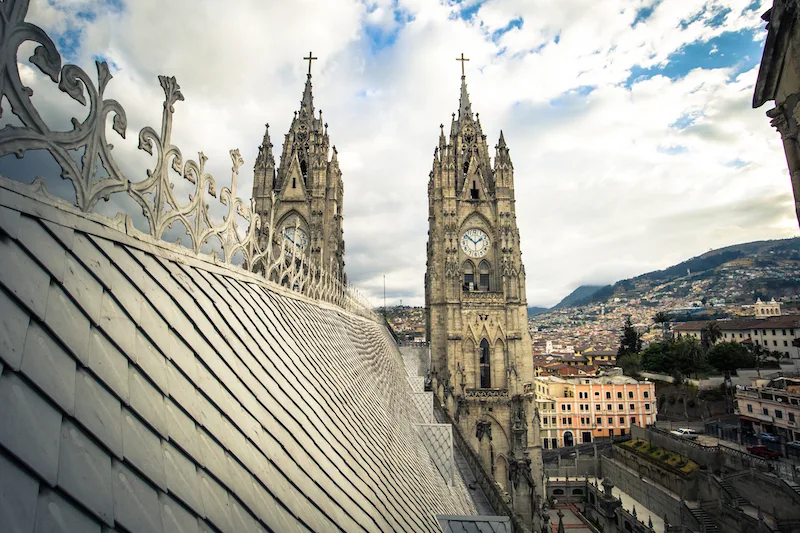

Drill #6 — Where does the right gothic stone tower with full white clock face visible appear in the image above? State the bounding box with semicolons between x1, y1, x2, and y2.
425;54;544;530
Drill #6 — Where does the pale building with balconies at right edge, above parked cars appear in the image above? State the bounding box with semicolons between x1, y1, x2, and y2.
736;377;800;441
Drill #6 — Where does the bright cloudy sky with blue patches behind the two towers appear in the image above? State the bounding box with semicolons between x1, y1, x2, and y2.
0;0;798;307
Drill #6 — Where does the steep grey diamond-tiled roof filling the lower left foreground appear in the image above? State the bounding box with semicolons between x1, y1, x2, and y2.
0;182;476;533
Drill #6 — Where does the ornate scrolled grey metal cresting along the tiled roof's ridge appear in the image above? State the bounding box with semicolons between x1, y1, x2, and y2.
0;0;377;320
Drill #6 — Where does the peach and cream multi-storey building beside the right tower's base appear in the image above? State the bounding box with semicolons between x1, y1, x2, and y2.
533;376;657;449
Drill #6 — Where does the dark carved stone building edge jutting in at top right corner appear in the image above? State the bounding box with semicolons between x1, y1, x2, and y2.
753;0;800;227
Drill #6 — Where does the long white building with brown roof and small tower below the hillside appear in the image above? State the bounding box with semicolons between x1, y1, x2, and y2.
672;315;800;361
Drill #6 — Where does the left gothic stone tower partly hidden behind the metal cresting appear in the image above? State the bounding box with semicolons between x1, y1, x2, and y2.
253;53;344;277
